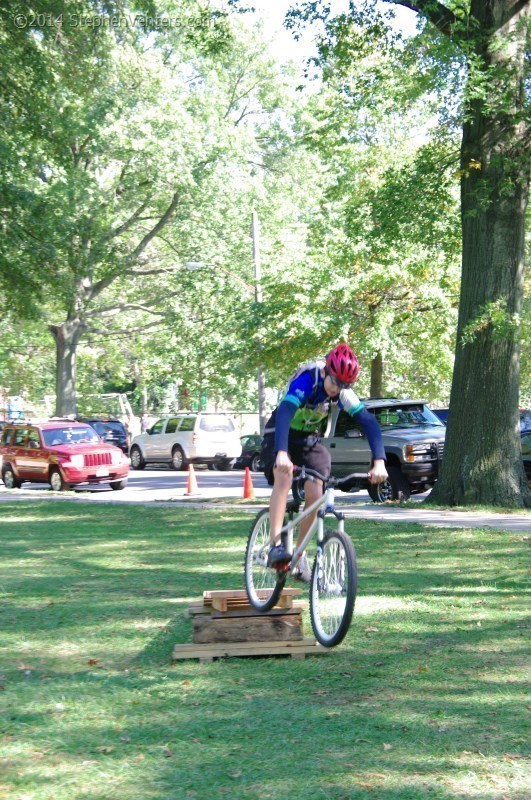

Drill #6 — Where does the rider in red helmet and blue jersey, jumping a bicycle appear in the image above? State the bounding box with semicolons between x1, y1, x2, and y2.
262;344;387;583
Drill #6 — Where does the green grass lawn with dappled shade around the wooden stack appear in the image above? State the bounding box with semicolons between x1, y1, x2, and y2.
0;502;531;800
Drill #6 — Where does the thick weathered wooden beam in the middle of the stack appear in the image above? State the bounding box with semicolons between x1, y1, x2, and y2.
192;614;303;644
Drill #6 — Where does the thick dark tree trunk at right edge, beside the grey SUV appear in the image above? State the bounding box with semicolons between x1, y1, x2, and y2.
432;0;531;507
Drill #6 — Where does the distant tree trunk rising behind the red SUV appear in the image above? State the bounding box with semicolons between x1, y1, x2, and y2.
50;318;86;417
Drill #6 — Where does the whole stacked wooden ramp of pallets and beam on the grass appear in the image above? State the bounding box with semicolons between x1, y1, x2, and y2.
173;588;327;661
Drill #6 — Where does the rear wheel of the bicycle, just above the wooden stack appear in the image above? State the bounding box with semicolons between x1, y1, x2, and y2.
245;509;287;611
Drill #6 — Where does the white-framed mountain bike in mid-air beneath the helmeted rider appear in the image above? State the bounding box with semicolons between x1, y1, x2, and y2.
245;467;367;647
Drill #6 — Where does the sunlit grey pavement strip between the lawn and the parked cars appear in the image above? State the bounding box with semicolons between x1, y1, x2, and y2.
0;467;531;535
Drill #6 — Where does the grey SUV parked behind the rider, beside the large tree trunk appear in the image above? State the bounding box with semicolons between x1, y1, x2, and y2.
323;398;446;502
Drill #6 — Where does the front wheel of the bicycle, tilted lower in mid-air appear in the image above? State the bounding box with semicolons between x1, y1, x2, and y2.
310;531;357;647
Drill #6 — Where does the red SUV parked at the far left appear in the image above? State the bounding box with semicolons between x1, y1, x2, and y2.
0;419;129;492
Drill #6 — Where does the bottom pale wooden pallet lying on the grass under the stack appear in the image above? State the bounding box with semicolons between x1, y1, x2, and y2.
173;639;328;662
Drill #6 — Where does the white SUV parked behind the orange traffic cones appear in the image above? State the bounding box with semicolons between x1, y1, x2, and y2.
130;412;242;470
